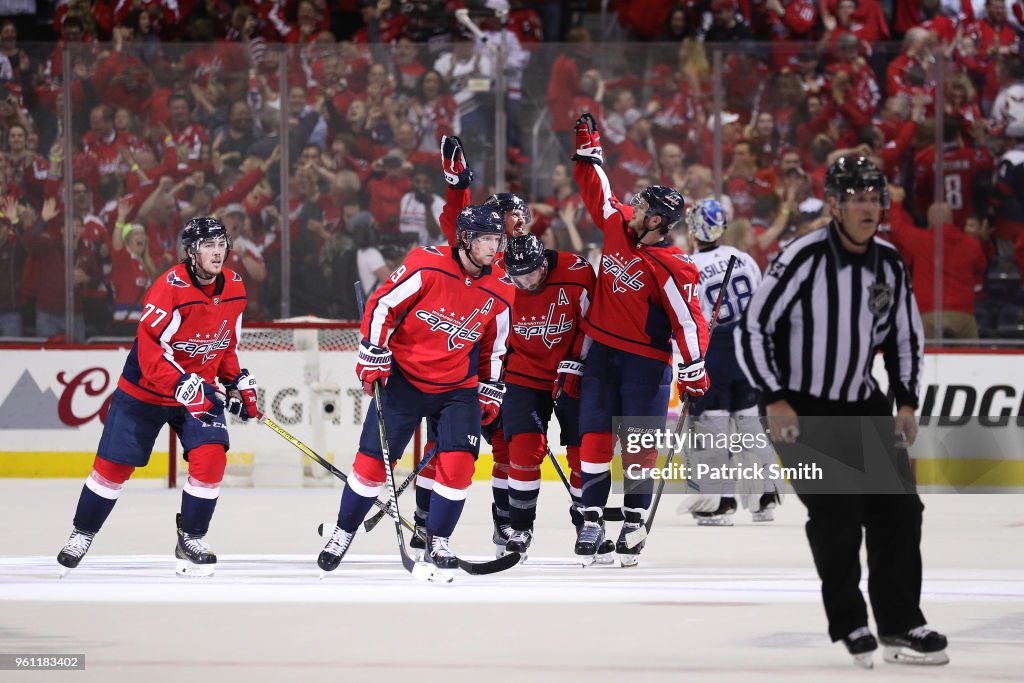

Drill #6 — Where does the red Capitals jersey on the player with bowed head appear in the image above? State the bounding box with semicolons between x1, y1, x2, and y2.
505;250;594;389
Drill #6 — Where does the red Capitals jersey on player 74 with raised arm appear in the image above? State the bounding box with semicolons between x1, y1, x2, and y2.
574;162;708;362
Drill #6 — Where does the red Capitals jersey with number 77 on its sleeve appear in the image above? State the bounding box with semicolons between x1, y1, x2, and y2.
118;263;246;405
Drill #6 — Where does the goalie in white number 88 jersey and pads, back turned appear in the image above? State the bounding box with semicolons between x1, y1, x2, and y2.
678;200;782;526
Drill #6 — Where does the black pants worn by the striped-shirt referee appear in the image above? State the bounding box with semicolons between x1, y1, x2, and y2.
776;393;925;642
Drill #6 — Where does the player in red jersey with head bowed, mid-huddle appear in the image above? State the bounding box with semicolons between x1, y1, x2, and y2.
492;233;598;560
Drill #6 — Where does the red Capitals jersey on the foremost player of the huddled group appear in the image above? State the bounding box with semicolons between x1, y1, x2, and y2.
360;247;514;393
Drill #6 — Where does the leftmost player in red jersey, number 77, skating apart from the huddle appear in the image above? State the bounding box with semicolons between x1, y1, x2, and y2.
57;217;257;577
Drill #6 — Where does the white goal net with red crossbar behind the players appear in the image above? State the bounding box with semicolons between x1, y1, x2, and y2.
177;316;414;487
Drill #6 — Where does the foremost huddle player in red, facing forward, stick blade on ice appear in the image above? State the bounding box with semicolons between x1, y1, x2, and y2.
317;206;514;571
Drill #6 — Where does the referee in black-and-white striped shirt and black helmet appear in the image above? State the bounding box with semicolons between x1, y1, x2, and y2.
736;157;948;668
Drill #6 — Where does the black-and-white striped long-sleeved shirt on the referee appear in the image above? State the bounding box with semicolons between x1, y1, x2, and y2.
736;224;925;408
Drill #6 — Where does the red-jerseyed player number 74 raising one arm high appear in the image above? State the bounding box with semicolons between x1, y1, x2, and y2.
573;114;710;566
